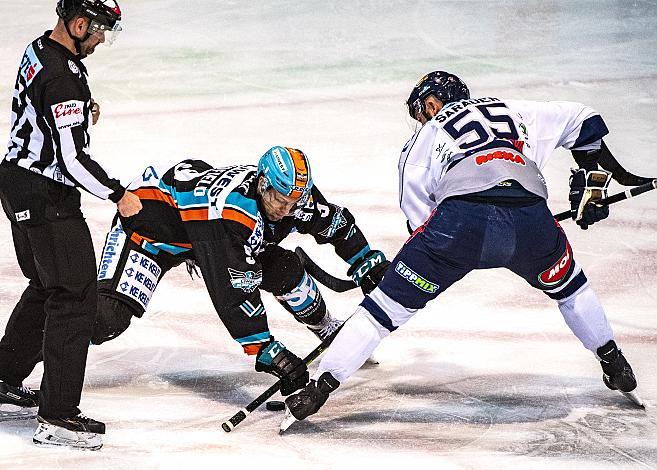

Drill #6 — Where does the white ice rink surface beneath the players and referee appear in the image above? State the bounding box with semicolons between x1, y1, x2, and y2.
0;0;657;470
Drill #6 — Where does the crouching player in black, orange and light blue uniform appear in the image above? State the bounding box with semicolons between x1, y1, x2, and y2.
92;147;388;395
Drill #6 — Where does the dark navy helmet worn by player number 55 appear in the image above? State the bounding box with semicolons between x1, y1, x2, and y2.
406;70;470;119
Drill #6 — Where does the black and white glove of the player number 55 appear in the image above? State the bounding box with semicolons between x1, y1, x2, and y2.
568;168;611;230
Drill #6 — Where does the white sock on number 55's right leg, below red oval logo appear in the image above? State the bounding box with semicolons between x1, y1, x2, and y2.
558;284;614;357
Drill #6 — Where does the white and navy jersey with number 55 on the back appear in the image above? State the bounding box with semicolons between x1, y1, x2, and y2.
399;97;608;230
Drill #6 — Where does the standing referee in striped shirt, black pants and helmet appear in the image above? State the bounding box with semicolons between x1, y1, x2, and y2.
0;0;141;449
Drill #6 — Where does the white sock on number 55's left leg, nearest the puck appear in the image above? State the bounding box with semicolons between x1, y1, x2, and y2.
313;306;390;382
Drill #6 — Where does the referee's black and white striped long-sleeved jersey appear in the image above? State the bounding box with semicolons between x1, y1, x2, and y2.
5;31;125;202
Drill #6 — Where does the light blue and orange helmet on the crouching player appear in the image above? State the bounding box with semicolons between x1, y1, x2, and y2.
258;146;313;199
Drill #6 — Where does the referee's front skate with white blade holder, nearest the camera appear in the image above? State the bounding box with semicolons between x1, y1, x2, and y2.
32;413;105;450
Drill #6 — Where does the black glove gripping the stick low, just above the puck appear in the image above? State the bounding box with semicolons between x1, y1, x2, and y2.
256;338;309;396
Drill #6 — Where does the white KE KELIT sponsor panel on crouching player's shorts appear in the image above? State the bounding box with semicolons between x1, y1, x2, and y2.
116;250;162;310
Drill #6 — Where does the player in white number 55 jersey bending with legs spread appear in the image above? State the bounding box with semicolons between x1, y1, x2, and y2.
281;71;650;429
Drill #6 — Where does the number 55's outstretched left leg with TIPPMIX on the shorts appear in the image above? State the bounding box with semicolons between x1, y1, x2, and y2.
281;218;470;420
